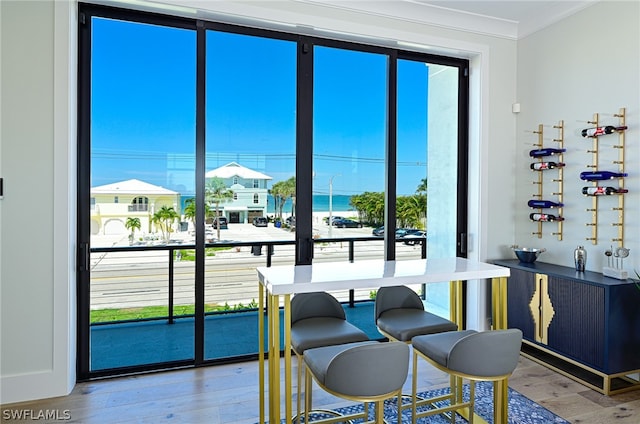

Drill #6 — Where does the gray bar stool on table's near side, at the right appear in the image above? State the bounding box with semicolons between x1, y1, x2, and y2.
412;329;522;424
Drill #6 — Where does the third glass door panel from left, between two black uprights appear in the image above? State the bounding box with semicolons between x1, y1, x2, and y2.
313;46;388;253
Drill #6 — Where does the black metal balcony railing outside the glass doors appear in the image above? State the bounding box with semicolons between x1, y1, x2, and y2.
90;237;426;325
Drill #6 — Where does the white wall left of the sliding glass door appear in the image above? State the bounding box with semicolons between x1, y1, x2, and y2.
0;1;75;403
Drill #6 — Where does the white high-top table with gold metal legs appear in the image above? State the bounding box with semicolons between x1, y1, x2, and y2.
257;258;510;424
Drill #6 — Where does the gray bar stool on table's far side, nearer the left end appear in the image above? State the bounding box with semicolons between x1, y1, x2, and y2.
291;292;369;423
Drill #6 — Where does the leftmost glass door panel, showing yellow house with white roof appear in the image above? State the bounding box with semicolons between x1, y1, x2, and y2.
86;17;196;371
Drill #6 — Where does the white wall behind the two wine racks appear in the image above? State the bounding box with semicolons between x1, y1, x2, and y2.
507;1;640;272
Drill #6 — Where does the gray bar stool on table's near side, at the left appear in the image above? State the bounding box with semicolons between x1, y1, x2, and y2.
304;341;409;424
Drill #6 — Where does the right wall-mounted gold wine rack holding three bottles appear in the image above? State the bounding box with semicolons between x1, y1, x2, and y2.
581;108;627;247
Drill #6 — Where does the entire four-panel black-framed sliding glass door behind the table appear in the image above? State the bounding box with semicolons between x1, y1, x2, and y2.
78;4;467;380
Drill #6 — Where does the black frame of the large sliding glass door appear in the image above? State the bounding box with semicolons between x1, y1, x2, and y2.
76;3;469;381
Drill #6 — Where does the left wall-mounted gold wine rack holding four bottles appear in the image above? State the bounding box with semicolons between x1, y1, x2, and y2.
528;121;565;240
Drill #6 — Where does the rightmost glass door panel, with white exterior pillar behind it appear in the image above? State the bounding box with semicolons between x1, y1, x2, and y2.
396;60;459;317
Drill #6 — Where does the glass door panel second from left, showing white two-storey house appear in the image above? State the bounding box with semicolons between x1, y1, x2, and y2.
204;31;296;359
